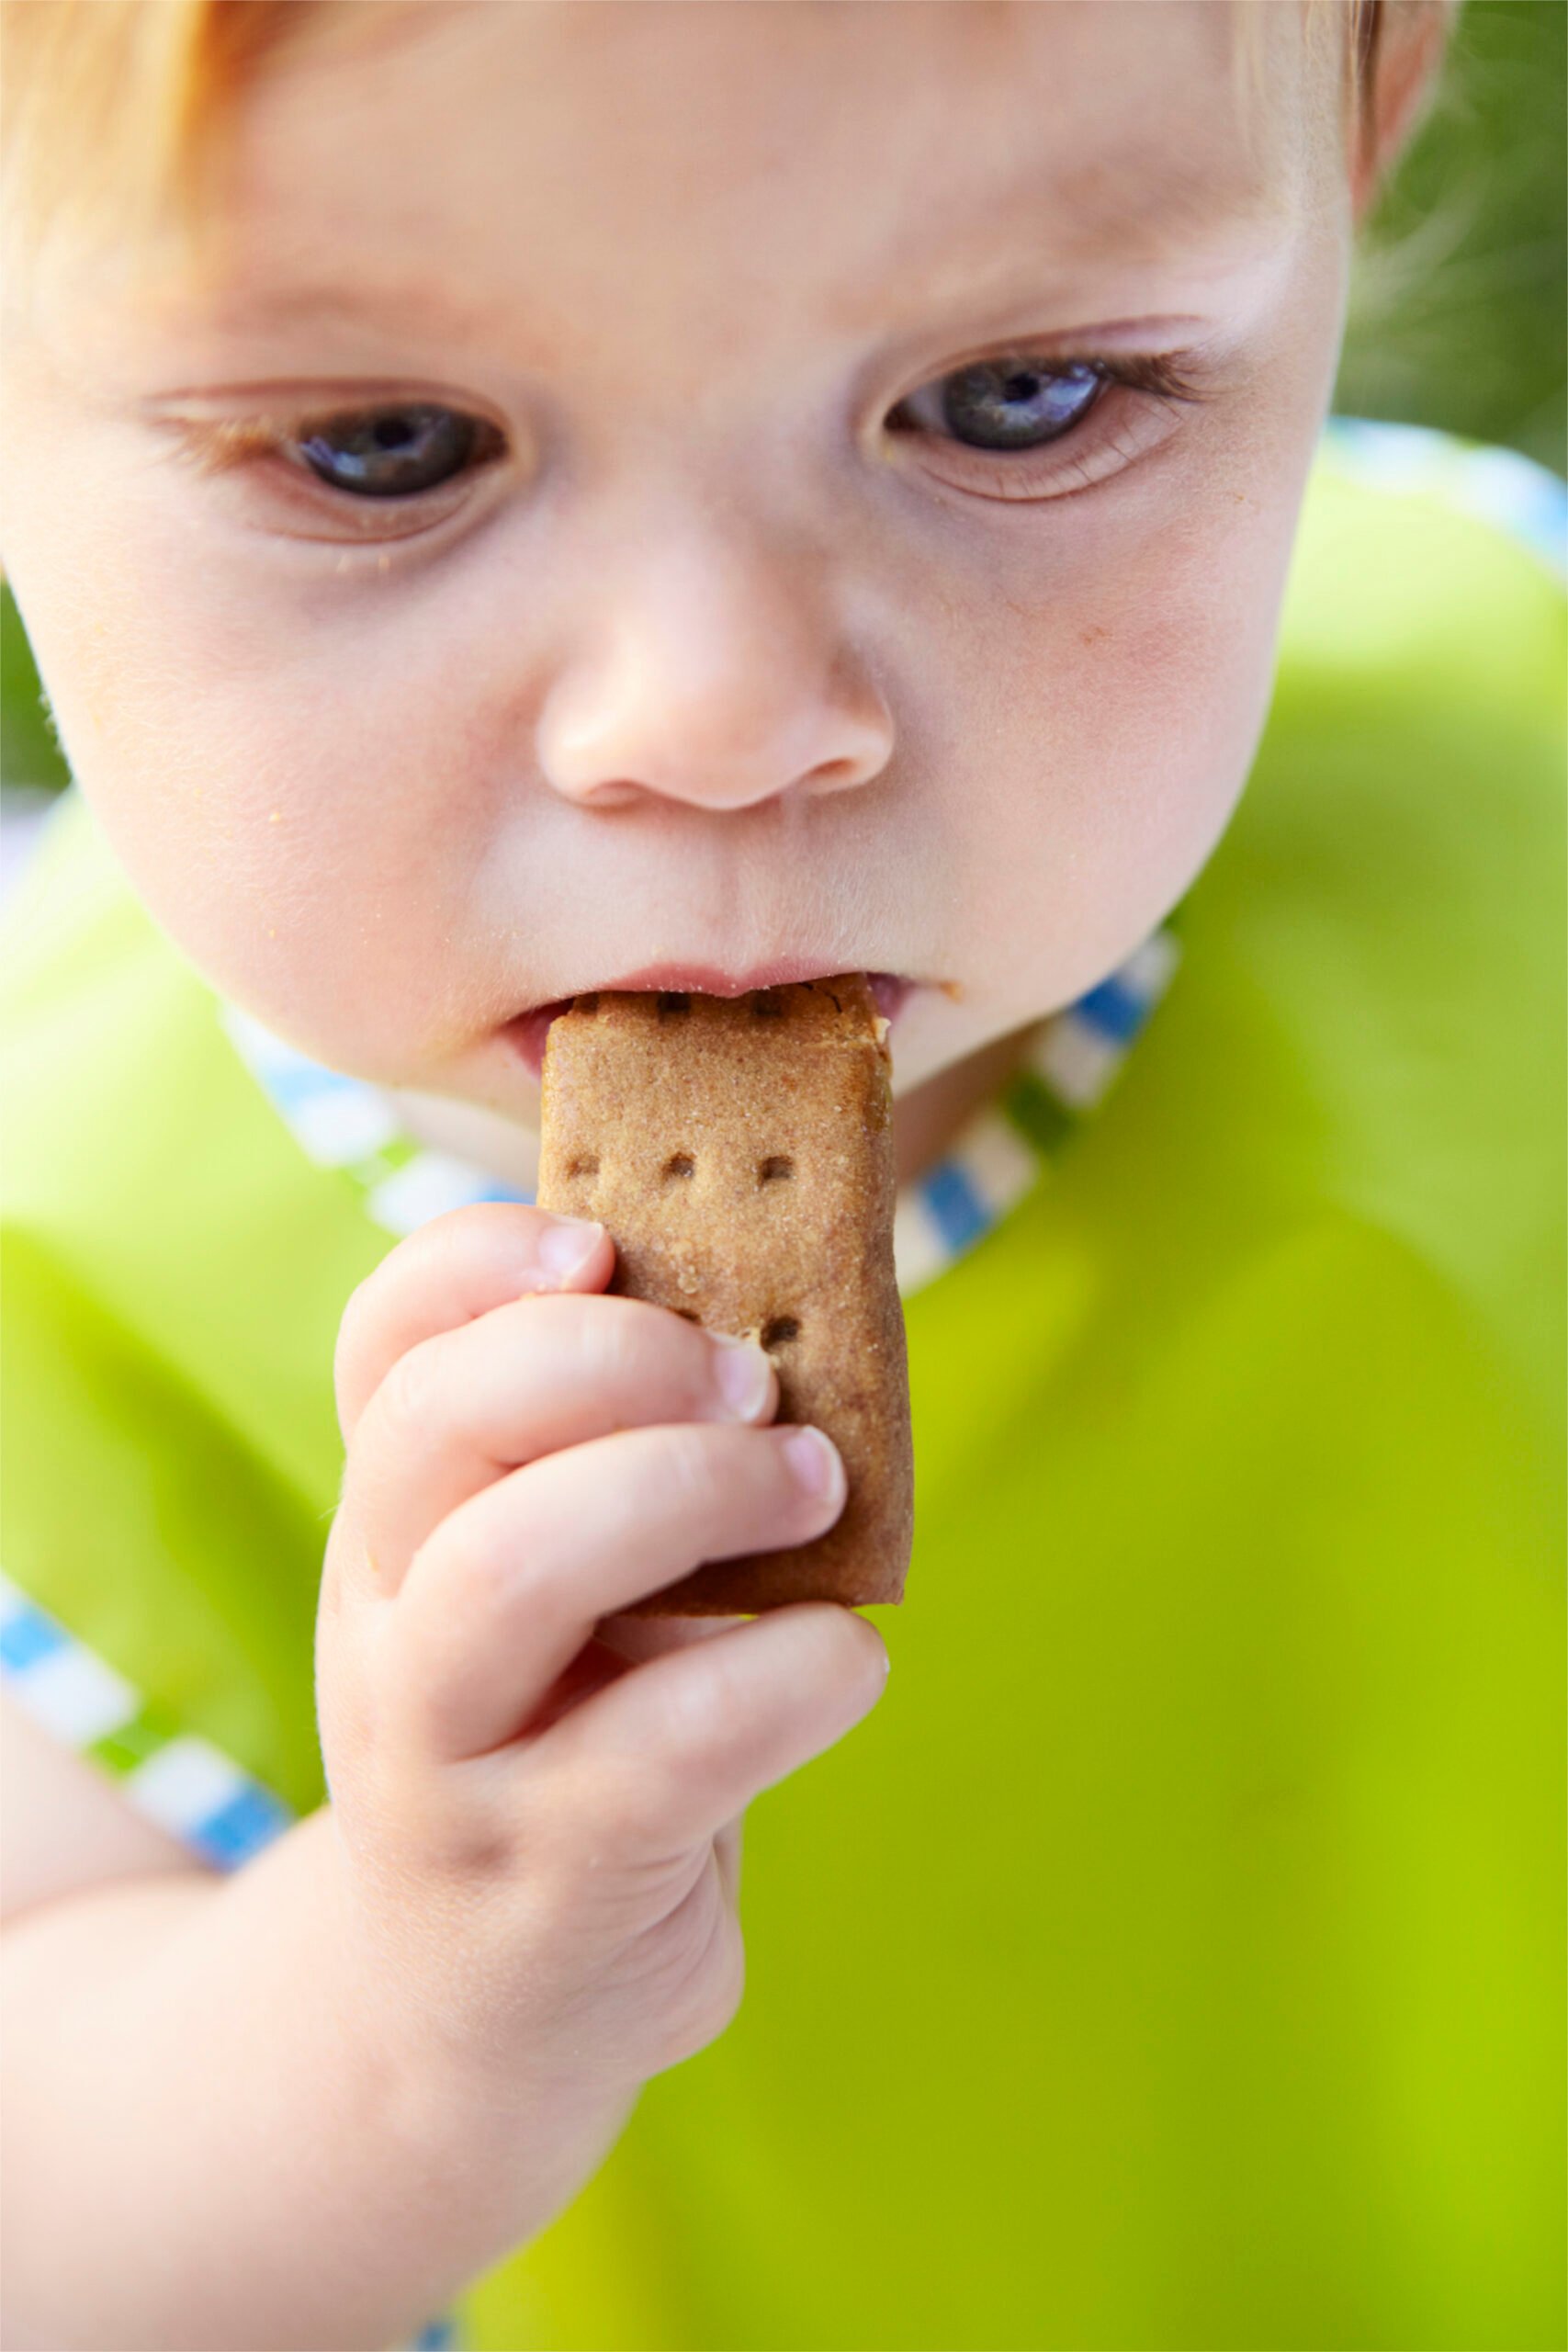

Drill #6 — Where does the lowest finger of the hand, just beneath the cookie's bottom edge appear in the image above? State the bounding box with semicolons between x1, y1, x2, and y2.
529;1601;888;1863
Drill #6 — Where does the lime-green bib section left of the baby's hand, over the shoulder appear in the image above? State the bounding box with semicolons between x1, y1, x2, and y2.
0;828;388;1811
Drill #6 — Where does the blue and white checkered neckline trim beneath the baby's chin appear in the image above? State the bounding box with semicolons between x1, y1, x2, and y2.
221;932;1176;1298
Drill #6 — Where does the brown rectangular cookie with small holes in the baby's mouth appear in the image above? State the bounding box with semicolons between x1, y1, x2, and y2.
538;971;915;1616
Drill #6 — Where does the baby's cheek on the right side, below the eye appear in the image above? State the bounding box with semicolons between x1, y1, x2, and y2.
954;435;1309;1016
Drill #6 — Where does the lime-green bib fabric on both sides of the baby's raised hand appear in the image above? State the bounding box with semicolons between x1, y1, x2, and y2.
0;444;1563;2352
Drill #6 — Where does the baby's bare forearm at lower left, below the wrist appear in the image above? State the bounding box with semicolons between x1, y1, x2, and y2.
0;1809;630;2352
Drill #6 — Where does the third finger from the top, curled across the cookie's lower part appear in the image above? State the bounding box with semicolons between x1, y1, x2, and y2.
378;1423;844;1769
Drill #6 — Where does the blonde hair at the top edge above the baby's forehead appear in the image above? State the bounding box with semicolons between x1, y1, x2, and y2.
0;0;1455;291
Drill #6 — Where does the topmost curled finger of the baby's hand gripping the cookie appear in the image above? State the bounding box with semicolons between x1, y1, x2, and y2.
333;1200;616;1440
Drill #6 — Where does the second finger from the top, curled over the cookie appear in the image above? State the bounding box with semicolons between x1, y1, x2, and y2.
344;1296;778;1597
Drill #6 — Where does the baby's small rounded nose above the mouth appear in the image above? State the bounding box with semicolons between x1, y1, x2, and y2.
538;532;894;814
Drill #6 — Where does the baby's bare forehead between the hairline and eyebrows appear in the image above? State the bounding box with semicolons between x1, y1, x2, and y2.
169;0;1312;365
